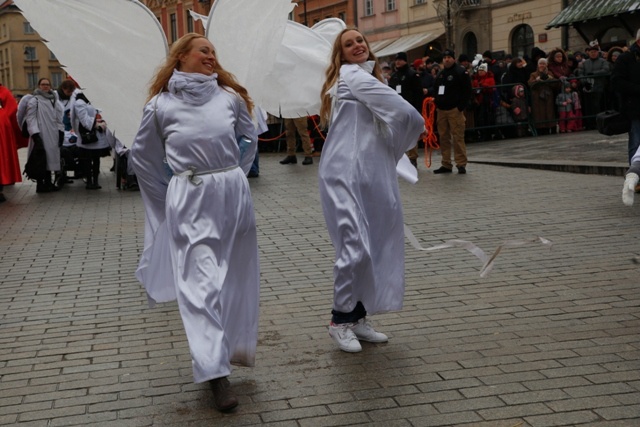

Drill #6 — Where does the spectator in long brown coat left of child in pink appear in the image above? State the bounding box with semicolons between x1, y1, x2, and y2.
528;58;558;135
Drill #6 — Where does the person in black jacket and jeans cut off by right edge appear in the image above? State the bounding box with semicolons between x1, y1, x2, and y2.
611;30;640;164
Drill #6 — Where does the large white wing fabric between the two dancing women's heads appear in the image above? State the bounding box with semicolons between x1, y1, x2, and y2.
206;0;346;117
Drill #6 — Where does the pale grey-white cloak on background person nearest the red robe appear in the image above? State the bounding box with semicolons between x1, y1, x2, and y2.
26;95;64;171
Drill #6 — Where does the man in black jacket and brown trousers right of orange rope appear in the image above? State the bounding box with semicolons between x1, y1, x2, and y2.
433;49;472;173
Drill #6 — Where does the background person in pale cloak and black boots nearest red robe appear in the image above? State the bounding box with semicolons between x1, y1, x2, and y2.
25;78;64;193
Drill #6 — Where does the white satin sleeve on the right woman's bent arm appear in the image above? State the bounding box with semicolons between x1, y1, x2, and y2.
340;64;424;161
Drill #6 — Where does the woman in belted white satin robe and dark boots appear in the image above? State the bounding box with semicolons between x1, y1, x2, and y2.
131;33;260;411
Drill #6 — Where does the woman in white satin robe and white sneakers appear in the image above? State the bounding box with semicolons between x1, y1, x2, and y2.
319;29;425;352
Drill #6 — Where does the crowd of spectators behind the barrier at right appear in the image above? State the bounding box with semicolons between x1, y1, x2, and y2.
381;41;627;142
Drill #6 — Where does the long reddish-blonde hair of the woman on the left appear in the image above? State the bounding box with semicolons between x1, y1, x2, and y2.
147;33;253;114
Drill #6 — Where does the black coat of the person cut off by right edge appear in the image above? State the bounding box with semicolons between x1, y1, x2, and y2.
611;43;640;120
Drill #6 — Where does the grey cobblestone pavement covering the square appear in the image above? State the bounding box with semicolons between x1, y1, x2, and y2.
0;132;640;427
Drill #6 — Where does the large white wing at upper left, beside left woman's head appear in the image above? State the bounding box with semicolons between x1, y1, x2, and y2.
14;0;168;146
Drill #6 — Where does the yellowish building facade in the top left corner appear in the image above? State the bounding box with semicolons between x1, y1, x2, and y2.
0;1;67;96
